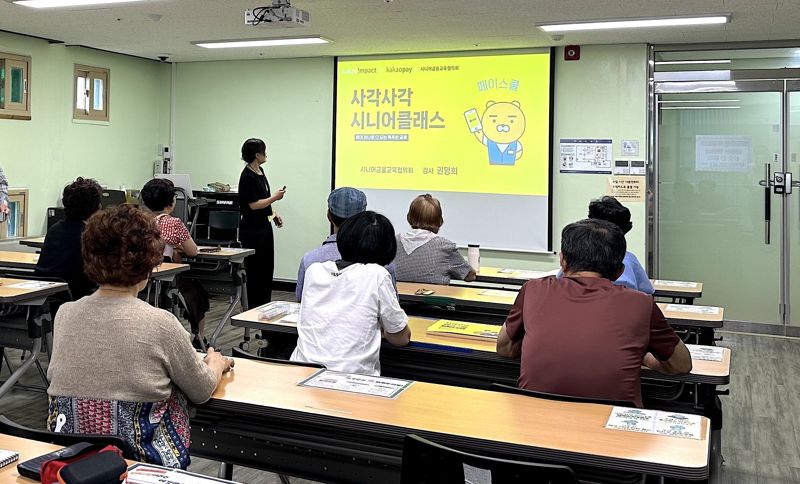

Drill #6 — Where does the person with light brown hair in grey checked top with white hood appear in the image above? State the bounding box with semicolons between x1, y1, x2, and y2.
394;193;475;284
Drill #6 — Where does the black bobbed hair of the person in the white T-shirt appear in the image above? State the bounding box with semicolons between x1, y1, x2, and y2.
336;210;397;266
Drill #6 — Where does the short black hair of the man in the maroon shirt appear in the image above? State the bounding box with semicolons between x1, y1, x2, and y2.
561;219;627;280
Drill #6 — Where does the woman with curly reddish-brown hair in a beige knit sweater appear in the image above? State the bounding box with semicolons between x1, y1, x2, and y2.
47;205;233;468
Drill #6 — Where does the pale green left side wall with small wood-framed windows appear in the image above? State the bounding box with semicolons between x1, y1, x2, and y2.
0;32;170;236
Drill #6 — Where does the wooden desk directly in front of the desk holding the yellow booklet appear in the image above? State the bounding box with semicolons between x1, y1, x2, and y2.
397;282;724;328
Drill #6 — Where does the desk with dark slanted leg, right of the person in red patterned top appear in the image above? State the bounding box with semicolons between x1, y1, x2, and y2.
186;246;256;346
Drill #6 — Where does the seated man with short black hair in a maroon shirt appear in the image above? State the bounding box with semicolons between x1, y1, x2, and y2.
497;219;692;407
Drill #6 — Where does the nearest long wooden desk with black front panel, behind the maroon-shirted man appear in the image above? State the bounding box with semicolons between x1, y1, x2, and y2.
191;359;710;484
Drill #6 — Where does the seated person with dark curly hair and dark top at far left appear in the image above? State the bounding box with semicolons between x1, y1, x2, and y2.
35;177;103;300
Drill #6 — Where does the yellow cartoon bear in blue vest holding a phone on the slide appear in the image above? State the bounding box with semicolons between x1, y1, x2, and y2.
474;101;525;166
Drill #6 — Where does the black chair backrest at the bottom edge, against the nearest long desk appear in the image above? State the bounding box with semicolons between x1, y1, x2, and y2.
400;434;578;484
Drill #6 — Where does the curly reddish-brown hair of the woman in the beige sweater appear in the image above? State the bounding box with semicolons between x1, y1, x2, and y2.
81;204;164;287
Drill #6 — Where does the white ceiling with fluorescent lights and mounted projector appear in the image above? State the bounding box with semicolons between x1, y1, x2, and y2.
0;0;800;62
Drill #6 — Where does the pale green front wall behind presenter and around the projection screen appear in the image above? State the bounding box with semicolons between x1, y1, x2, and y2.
174;44;647;280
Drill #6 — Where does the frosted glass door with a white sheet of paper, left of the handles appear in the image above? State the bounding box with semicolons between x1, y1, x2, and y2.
655;87;784;324
